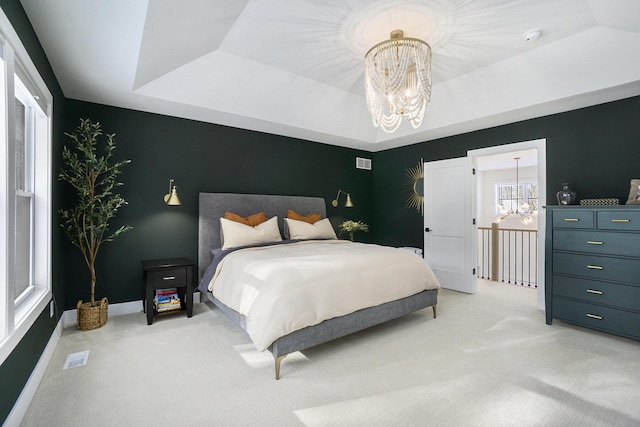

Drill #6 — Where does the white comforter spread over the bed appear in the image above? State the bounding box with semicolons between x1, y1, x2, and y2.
208;240;440;351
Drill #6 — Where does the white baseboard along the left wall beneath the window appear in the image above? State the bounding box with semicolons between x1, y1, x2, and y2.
2;318;63;427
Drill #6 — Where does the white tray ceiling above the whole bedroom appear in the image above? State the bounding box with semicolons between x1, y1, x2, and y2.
21;0;640;151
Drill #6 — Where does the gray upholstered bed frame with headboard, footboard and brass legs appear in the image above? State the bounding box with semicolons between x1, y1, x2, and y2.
198;193;439;379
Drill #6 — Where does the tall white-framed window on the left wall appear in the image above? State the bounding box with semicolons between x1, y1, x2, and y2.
0;11;53;363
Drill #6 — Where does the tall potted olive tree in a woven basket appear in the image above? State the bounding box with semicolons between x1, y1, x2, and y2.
58;119;131;330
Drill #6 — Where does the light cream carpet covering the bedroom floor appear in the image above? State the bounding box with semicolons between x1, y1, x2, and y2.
23;281;640;426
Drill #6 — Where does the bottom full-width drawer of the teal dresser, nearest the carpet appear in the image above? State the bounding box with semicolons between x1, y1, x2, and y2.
553;298;640;338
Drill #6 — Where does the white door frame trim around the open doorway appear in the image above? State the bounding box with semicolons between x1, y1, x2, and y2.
467;138;547;310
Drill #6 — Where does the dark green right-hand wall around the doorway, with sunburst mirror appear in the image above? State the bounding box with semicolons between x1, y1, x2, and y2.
373;97;640;248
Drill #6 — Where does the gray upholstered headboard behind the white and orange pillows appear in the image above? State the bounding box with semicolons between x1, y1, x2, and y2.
198;193;327;280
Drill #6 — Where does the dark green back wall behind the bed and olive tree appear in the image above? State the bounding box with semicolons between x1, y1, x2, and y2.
56;100;372;309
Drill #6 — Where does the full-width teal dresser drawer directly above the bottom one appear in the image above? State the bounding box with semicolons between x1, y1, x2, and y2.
553;276;640;311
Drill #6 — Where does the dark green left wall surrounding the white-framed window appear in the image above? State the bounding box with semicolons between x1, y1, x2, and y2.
0;0;65;420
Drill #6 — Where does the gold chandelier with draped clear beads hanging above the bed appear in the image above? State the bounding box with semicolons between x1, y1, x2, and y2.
364;30;431;133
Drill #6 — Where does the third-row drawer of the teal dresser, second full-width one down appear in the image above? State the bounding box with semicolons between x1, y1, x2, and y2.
553;252;640;286
